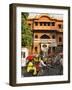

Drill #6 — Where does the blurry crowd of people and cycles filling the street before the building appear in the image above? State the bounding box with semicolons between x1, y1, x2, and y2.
23;53;63;76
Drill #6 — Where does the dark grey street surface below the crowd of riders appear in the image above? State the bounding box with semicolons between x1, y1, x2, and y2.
22;65;63;77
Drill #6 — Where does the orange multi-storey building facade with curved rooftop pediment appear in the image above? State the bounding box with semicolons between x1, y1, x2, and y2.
27;14;63;54
